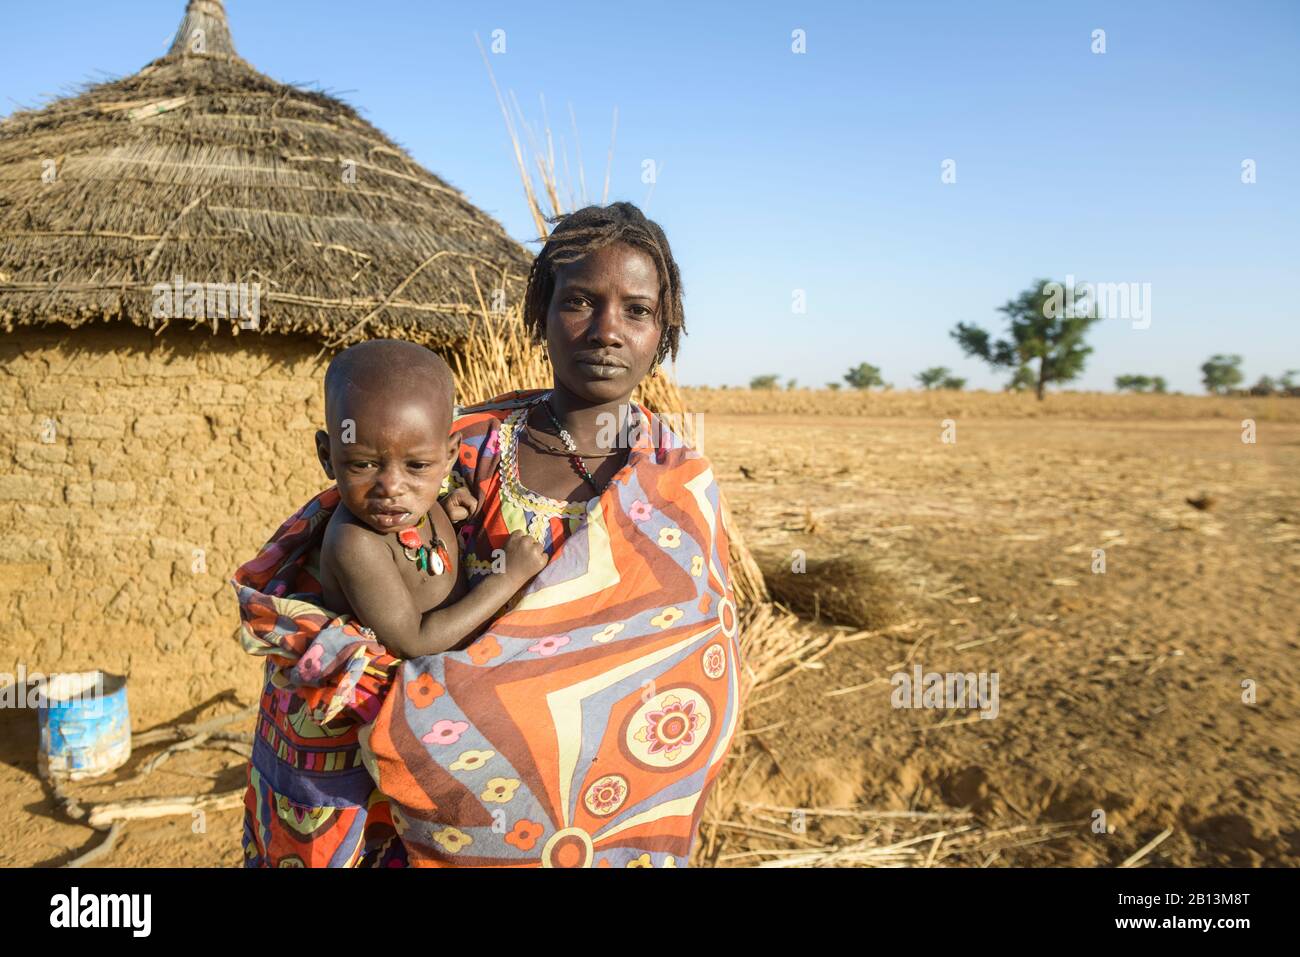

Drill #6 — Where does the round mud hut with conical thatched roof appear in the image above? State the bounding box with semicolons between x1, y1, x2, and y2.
0;0;548;722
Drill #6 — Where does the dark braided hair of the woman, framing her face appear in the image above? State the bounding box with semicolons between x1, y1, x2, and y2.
524;203;686;365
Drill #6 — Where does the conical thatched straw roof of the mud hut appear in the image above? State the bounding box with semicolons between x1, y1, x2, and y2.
0;0;529;346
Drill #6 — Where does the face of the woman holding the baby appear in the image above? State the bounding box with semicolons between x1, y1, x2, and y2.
546;243;662;404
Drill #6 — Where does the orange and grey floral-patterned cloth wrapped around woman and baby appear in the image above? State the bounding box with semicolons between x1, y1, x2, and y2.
235;393;742;867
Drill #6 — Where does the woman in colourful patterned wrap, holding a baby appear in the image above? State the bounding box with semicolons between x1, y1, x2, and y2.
235;203;741;866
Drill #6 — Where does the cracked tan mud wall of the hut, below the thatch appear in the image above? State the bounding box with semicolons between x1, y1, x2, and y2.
0;325;328;729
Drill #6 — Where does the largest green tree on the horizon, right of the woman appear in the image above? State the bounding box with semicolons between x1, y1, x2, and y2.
952;280;1099;399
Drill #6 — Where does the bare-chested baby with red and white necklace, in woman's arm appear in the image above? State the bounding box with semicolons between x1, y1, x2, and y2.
316;339;547;658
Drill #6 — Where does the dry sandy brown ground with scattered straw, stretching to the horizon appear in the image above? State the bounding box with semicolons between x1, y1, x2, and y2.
0;391;1300;866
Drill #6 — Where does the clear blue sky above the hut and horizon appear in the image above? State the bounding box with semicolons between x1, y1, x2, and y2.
0;0;1300;391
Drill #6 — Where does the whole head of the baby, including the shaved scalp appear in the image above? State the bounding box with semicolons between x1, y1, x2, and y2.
316;339;460;533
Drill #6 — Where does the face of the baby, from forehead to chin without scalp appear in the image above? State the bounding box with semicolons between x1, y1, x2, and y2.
317;393;459;533
